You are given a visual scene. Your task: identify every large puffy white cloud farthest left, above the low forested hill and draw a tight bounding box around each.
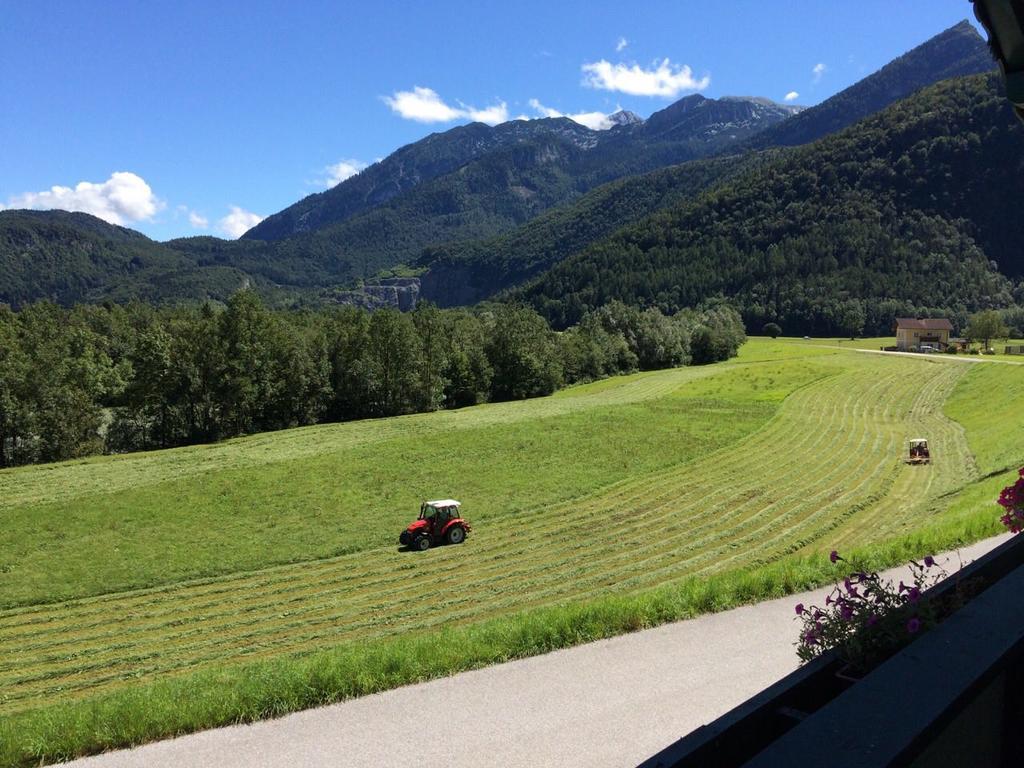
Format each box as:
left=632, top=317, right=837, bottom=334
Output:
left=5, top=171, right=165, bottom=225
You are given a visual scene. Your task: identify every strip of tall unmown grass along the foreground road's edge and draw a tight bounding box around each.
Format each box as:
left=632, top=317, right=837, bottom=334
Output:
left=0, top=495, right=1000, bottom=767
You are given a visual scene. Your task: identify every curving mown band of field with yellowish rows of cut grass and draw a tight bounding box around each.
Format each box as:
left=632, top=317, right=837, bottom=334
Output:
left=0, top=355, right=966, bottom=713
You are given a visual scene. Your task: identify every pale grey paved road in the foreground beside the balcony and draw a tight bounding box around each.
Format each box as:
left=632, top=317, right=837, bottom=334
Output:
left=58, top=537, right=1006, bottom=768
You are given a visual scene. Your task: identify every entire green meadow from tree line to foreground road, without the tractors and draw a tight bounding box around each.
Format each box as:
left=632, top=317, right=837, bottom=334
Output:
left=0, top=340, right=1024, bottom=763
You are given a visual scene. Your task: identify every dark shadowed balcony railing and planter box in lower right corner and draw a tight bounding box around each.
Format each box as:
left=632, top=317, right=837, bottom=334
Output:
left=641, top=537, right=1024, bottom=768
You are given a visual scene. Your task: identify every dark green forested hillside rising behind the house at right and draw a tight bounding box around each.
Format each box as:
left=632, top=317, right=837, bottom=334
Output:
left=515, top=75, right=1024, bottom=334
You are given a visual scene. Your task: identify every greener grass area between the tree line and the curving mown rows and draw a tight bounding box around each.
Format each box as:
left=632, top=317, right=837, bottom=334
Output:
left=0, top=364, right=782, bottom=607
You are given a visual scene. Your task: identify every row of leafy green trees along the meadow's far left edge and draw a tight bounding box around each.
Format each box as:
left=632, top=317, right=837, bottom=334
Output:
left=0, top=291, right=745, bottom=467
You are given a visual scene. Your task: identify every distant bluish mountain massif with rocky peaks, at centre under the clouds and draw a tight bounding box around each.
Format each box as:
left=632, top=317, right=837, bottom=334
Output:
left=244, top=95, right=799, bottom=264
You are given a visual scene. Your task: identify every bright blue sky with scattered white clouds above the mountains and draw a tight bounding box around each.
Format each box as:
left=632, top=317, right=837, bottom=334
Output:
left=0, top=0, right=977, bottom=240
